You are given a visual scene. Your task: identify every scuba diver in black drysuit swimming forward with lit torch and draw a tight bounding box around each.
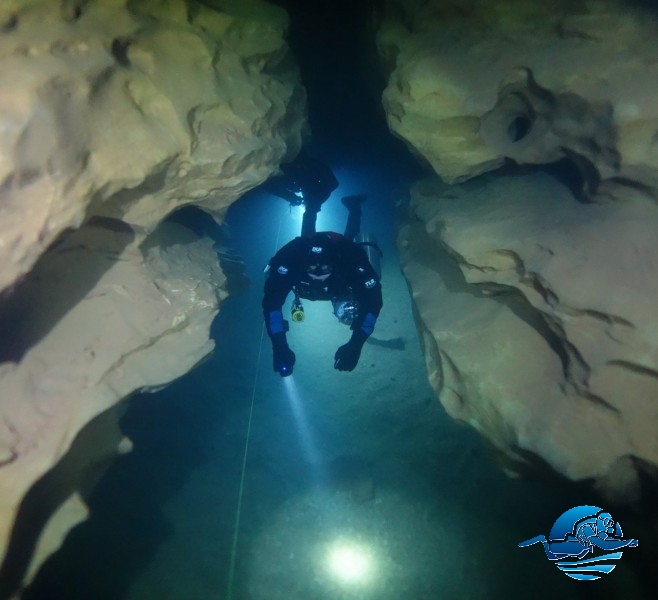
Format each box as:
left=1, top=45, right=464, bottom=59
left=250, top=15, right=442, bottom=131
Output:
left=263, top=157, right=383, bottom=377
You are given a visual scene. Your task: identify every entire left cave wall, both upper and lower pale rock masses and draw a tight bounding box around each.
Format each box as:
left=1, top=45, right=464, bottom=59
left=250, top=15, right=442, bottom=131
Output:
left=0, top=0, right=308, bottom=597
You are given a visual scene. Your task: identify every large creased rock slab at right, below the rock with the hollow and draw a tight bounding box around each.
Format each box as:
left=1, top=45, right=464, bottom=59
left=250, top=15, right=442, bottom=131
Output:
left=400, top=175, right=658, bottom=502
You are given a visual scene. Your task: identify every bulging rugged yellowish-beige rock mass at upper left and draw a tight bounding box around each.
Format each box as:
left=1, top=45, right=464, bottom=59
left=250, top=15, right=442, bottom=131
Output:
left=0, top=0, right=307, bottom=290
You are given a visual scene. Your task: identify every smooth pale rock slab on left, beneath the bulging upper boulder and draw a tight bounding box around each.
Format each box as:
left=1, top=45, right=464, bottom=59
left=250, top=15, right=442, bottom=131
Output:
left=0, top=220, right=225, bottom=587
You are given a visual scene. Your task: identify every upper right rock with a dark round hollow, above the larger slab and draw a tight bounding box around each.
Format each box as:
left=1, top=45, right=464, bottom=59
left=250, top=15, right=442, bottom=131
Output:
left=378, top=0, right=658, bottom=201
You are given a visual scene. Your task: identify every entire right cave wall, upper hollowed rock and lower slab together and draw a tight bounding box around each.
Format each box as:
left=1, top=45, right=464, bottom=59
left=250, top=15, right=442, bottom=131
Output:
left=378, top=0, right=658, bottom=504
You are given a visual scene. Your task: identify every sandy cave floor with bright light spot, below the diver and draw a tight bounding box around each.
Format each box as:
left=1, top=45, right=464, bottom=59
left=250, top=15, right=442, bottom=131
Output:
left=116, top=207, right=630, bottom=600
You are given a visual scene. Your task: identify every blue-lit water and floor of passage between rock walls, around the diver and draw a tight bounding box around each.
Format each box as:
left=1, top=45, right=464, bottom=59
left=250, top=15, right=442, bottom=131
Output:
left=19, top=0, right=648, bottom=600
